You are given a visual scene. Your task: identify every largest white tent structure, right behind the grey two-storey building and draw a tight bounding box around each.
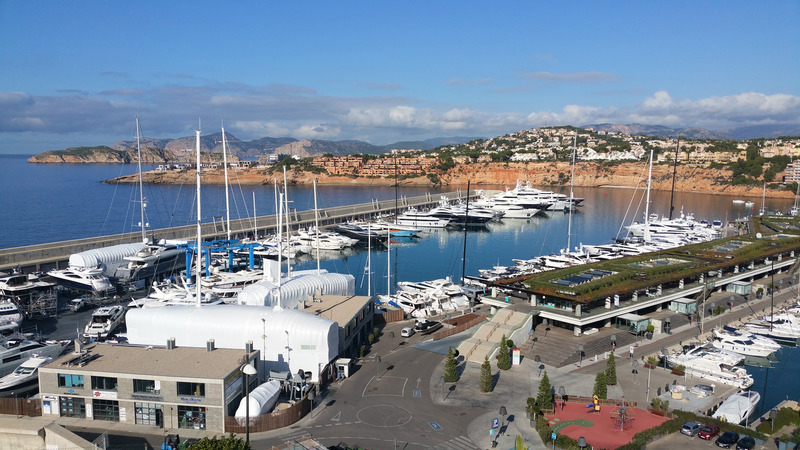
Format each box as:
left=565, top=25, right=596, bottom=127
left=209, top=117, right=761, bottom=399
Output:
left=125, top=305, right=339, bottom=382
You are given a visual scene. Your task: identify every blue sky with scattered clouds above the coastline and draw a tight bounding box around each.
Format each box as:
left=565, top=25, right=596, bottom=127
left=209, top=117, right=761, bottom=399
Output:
left=0, top=0, right=800, bottom=154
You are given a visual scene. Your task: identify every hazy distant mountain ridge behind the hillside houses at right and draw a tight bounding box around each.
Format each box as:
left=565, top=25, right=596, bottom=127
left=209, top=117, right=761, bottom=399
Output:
left=582, top=123, right=800, bottom=141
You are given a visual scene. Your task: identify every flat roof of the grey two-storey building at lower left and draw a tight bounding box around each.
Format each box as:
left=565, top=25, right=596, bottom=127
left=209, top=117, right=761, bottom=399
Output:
left=44, top=342, right=255, bottom=379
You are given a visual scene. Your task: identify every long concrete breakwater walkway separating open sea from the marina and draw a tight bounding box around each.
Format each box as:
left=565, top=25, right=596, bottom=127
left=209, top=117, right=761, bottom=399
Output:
left=0, top=190, right=477, bottom=273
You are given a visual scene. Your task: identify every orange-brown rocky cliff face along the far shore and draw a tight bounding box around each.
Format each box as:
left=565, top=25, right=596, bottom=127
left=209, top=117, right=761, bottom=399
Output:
left=108, top=162, right=794, bottom=198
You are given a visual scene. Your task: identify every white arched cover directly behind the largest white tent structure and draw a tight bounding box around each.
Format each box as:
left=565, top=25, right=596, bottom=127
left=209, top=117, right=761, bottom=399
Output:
left=237, top=270, right=356, bottom=309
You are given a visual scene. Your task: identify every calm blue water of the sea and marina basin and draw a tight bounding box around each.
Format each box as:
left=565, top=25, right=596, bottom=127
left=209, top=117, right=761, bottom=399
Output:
left=0, top=155, right=800, bottom=410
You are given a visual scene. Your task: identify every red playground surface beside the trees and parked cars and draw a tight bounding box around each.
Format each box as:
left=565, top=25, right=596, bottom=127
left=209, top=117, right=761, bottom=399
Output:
left=547, top=402, right=669, bottom=449
